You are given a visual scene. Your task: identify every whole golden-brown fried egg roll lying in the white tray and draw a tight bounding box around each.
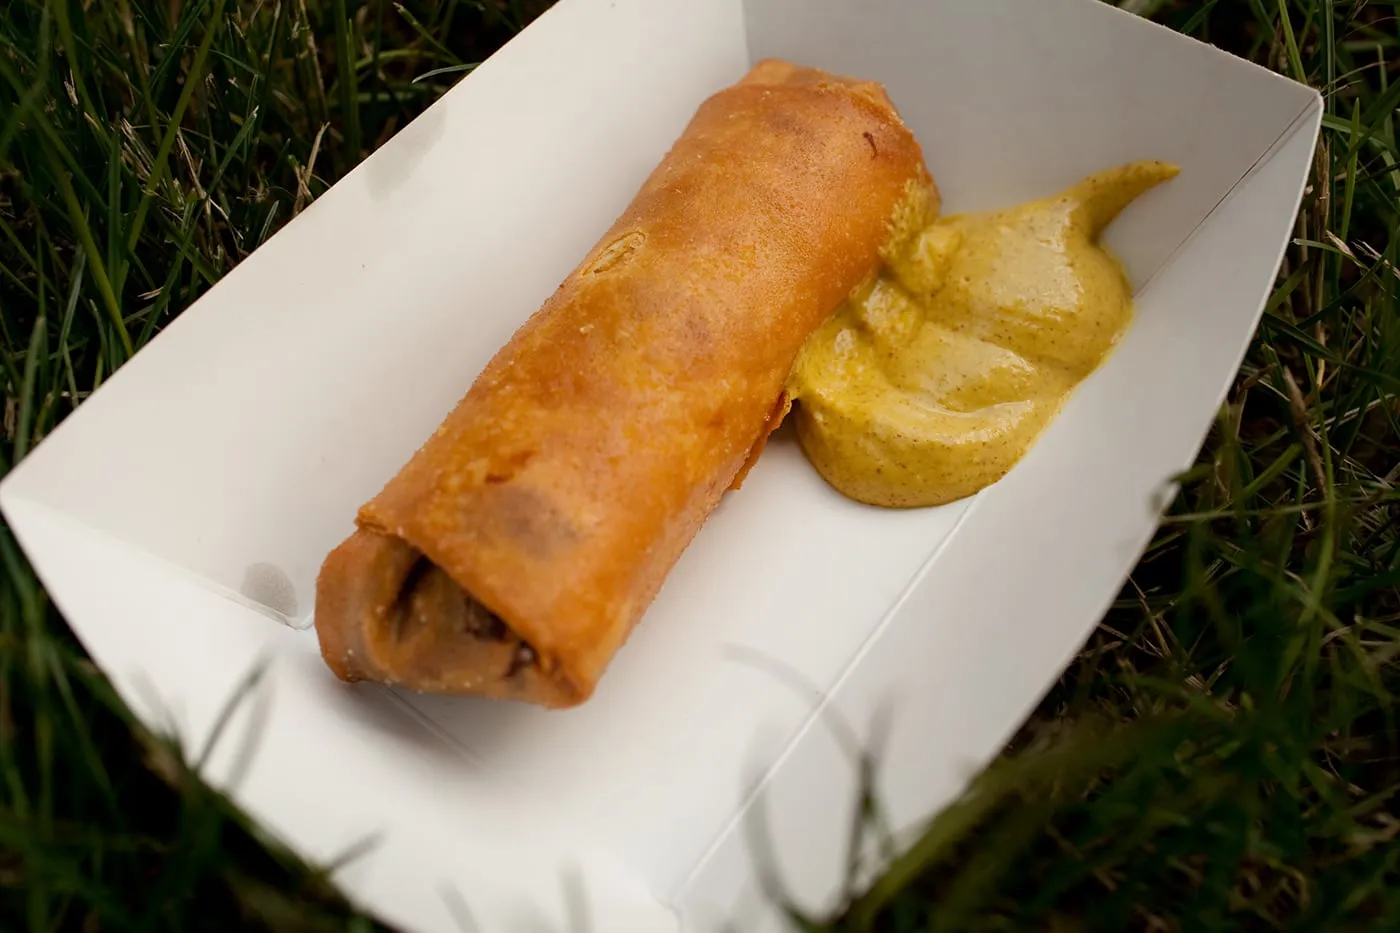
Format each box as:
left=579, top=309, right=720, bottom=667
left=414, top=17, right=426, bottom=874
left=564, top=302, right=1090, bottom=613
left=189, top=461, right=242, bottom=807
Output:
left=315, top=60, right=937, bottom=706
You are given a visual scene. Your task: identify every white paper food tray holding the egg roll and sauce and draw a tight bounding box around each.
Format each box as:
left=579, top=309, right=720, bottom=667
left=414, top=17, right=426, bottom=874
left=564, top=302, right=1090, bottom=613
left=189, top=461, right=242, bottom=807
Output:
left=0, top=0, right=1322, bottom=933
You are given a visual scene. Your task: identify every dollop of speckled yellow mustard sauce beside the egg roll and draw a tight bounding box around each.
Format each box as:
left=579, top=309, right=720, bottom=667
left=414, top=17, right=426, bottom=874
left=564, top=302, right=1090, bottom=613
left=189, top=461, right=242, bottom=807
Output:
left=788, top=161, right=1177, bottom=507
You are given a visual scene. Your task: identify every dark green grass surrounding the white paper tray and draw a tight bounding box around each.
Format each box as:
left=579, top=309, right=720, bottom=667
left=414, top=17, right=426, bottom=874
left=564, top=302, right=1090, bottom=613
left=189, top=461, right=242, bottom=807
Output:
left=0, top=0, right=1400, bottom=933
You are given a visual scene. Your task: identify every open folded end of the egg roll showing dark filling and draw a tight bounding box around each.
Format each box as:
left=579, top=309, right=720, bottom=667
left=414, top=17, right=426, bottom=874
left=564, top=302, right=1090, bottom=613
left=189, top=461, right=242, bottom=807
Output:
left=316, top=528, right=587, bottom=707
